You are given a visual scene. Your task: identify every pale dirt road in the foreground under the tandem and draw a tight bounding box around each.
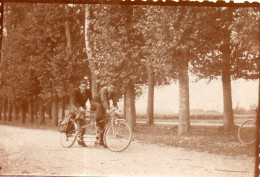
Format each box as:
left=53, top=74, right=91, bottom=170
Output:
left=0, top=125, right=254, bottom=177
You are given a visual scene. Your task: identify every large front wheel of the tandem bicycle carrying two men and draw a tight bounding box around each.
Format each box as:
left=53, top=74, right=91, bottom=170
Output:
left=104, top=120, right=132, bottom=152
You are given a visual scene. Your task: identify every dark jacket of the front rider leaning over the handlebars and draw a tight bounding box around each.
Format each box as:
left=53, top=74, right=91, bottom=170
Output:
left=93, top=87, right=118, bottom=110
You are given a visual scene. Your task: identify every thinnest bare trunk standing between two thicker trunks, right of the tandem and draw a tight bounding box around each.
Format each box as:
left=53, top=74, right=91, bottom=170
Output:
left=146, top=64, right=154, bottom=124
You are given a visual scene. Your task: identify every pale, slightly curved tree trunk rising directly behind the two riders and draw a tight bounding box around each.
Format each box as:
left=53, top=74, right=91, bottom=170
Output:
left=85, top=4, right=99, bottom=97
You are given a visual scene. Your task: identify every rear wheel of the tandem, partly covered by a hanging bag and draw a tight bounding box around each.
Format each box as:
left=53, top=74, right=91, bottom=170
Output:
left=60, top=123, right=77, bottom=148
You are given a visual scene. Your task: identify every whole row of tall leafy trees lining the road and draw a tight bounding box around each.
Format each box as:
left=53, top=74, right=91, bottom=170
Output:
left=1, top=3, right=260, bottom=135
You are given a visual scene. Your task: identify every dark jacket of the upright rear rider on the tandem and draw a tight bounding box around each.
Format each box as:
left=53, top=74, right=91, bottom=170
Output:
left=72, top=89, right=92, bottom=108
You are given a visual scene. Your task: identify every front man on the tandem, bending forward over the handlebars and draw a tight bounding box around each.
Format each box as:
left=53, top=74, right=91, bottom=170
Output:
left=92, top=80, right=118, bottom=148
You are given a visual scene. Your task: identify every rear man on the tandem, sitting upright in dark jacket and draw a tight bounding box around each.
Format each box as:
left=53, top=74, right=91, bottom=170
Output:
left=71, top=80, right=92, bottom=147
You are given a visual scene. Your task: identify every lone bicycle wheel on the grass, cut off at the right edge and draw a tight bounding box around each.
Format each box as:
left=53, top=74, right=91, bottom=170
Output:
left=238, top=120, right=256, bottom=144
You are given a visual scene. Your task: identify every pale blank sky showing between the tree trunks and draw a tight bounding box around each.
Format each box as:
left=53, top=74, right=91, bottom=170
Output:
left=119, top=79, right=259, bottom=114
